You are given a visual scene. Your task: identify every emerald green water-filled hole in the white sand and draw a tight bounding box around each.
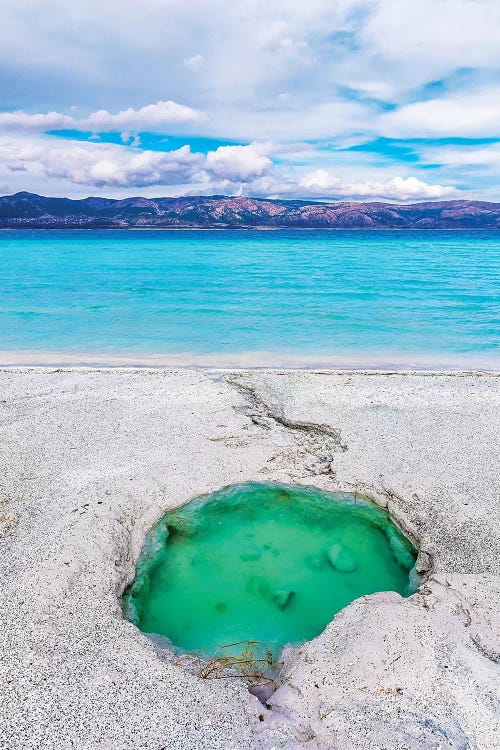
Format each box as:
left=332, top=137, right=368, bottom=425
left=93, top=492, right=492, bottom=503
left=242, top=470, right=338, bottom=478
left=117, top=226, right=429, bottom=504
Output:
left=124, top=483, right=418, bottom=658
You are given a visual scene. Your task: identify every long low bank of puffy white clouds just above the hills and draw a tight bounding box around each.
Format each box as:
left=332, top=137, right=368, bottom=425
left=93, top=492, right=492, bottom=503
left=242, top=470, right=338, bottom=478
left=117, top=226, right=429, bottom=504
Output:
left=0, top=136, right=459, bottom=201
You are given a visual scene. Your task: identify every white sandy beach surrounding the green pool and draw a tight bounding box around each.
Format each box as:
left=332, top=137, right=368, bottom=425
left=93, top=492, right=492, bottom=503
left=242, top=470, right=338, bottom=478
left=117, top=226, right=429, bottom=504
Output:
left=0, top=367, right=500, bottom=750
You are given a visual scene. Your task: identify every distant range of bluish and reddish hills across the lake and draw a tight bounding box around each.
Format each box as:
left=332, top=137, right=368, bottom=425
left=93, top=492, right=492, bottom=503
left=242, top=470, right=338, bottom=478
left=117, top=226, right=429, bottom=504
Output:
left=0, top=193, right=500, bottom=229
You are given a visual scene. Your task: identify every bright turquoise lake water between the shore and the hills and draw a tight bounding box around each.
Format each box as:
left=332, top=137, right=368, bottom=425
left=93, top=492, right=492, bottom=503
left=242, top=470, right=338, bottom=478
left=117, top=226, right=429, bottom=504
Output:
left=0, top=231, right=500, bottom=364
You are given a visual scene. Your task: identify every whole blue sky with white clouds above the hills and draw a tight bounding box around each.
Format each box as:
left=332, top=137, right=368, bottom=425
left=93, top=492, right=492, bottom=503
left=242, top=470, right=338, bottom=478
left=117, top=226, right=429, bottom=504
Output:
left=0, top=0, right=500, bottom=202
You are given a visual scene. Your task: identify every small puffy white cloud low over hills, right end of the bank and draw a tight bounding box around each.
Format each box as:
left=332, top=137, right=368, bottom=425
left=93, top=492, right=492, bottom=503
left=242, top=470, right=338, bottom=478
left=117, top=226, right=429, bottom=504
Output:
left=299, top=169, right=459, bottom=201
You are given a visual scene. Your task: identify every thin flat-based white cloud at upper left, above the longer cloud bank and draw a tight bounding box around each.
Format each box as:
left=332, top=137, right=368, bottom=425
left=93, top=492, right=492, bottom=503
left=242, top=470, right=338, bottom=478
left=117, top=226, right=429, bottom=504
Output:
left=0, top=100, right=206, bottom=133
